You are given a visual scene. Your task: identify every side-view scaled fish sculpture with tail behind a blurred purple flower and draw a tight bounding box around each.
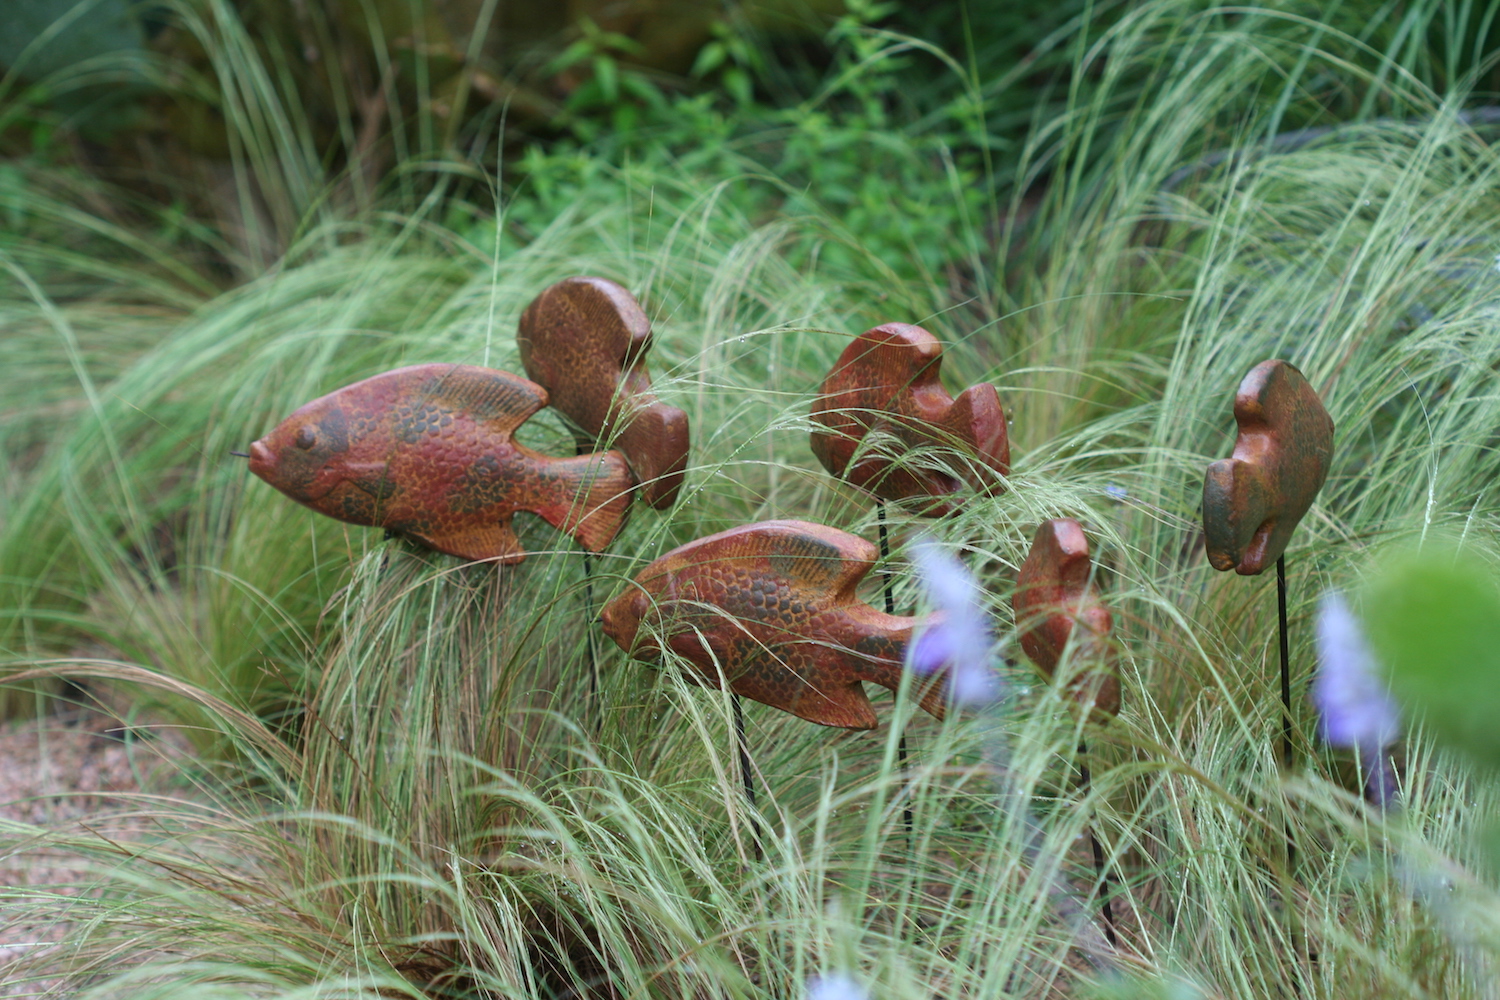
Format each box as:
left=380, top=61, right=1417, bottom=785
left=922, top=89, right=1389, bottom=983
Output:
left=600, top=520, right=947, bottom=729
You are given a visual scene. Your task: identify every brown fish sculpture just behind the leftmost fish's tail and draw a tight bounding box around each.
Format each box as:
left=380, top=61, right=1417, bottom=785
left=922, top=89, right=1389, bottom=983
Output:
left=516, top=277, right=689, bottom=508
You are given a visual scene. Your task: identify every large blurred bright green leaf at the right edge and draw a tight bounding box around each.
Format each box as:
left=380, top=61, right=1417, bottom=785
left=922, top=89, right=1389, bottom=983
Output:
left=1364, top=547, right=1500, bottom=771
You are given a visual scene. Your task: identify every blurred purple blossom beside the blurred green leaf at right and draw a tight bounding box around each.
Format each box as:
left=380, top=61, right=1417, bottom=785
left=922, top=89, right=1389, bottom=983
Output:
left=1313, top=591, right=1401, bottom=807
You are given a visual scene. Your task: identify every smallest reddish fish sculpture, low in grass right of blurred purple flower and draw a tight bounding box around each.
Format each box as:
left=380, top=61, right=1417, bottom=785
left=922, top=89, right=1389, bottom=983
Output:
left=1011, top=517, right=1121, bottom=715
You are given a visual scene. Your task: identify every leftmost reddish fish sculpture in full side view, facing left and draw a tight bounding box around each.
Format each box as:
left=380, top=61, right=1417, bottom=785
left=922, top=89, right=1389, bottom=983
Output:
left=251, top=364, right=633, bottom=562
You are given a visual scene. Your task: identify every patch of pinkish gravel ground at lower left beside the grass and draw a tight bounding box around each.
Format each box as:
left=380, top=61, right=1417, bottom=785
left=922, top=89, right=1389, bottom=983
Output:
left=0, top=709, right=189, bottom=999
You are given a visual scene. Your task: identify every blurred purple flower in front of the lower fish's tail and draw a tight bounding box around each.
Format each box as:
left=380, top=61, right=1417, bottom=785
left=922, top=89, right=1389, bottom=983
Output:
left=906, top=538, right=1001, bottom=706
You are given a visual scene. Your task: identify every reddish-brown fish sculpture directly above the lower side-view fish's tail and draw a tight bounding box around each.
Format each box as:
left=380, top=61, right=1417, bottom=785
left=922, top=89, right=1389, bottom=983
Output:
left=812, top=322, right=1011, bottom=516
